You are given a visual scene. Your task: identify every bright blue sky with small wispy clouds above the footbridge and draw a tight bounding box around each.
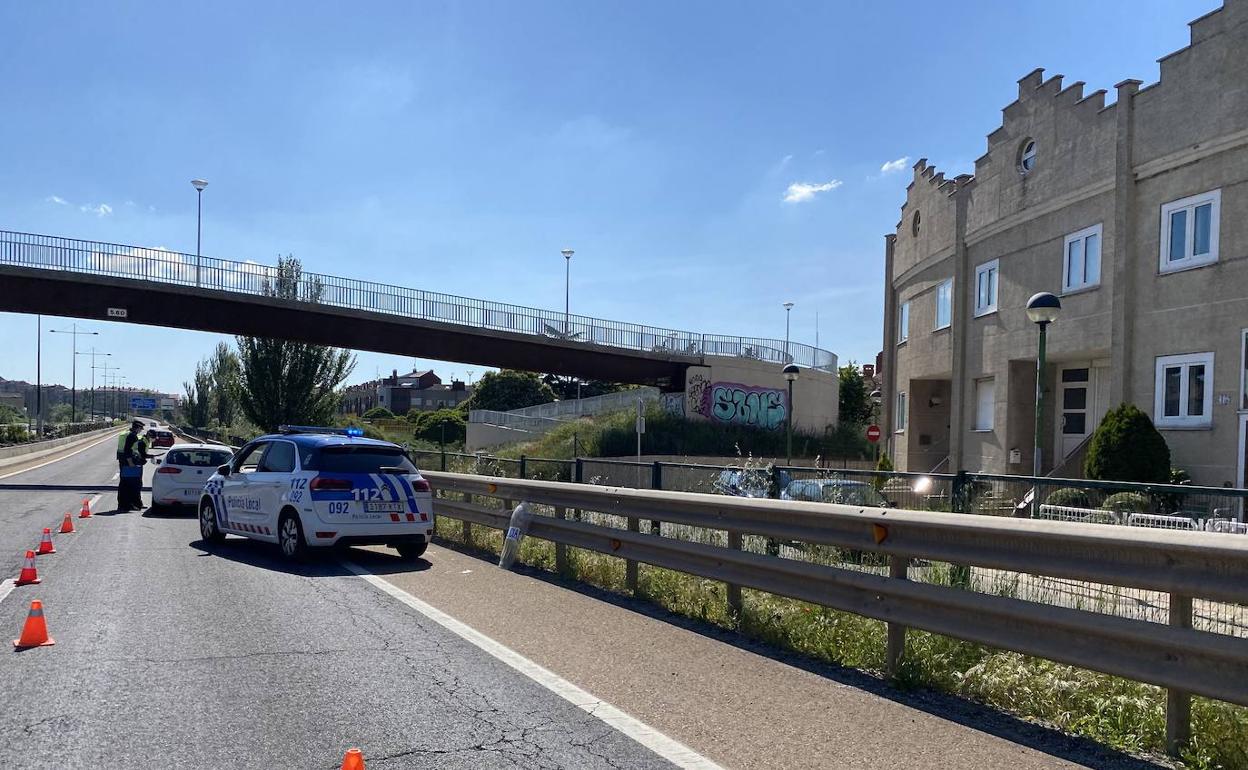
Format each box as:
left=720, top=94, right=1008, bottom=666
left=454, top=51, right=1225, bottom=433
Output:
left=0, top=0, right=1217, bottom=391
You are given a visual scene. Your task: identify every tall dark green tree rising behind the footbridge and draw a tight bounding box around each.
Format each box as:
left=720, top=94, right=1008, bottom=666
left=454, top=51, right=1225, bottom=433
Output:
left=237, top=256, right=356, bottom=431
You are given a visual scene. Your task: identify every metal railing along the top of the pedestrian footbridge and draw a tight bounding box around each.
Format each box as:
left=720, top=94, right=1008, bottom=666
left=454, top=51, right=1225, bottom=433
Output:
left=0, top=231, right=836, bottom=372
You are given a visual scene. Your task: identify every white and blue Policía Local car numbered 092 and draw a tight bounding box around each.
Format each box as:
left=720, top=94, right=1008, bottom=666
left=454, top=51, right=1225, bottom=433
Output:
left=200, top=426, right=433, bottom=559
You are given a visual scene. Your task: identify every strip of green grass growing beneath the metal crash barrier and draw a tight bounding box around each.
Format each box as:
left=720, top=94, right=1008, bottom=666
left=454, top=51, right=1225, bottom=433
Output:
left=437, top=506, right=1248, bottom=770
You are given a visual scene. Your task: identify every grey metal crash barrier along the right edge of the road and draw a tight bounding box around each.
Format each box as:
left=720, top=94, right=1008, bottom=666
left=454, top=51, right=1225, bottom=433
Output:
left=426, top=472, right=1248, bottom=750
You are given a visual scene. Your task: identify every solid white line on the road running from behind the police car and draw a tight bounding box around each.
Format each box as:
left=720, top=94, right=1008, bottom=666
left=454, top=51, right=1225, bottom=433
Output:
left=342, top=562, right=723, bottom=770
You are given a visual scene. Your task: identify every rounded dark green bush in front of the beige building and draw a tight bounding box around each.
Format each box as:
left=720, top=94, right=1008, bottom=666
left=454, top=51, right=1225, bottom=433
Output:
left=1083, top=403, right=1171, bottom=484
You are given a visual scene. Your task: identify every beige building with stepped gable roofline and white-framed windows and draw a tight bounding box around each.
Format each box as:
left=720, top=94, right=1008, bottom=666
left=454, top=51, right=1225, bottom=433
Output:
left=884, top=0, right=1248, bottom=485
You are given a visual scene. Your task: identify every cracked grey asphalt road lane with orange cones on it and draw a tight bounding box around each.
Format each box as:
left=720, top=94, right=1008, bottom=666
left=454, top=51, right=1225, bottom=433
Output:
left=0, top=439, right=673, bottom=769
